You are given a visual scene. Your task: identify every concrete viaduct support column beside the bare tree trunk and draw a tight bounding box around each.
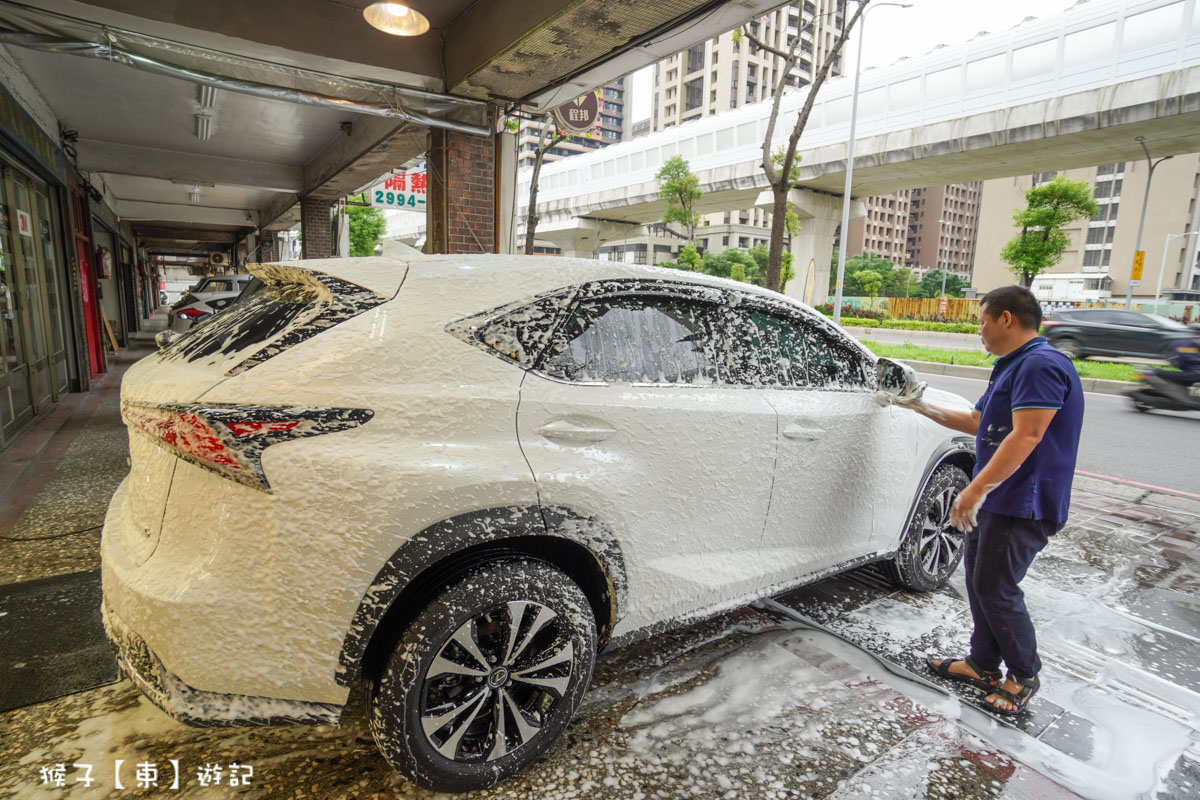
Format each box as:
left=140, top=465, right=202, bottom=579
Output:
left=755, top=188, right=866, bottom=306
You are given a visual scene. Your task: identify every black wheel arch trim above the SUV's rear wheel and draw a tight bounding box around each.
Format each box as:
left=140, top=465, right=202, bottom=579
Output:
left=335, top=506, right=629, bottom=687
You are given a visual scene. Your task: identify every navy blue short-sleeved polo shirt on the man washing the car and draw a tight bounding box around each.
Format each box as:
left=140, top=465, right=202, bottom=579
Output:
left=974, top=336, right=1084, bottom=522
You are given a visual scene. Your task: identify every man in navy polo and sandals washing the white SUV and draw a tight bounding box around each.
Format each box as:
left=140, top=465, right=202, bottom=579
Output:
left=898, top=285, right=1084, bottom=716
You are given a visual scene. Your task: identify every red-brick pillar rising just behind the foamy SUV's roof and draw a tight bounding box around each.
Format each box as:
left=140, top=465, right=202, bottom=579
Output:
left=425, top=128, right=497, bottom=253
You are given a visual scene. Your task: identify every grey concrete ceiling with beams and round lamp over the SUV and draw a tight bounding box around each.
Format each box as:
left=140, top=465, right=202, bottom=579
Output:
left=0, top=0, right=781, bottom=250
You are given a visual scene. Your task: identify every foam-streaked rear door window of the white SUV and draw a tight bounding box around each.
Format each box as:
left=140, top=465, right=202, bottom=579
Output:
left=542, top=295, right=722, bottom=384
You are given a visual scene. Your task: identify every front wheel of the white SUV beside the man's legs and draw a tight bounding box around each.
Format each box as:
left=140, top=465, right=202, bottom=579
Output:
left=883, top=464, right=971, bottom=591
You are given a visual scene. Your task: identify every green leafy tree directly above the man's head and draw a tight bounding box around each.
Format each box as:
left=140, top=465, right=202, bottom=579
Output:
left=1000, top=175, right=1099, bottom=287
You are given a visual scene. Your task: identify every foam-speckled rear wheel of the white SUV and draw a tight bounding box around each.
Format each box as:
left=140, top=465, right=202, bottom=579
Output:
left=366, top=559, right=596, bottom=792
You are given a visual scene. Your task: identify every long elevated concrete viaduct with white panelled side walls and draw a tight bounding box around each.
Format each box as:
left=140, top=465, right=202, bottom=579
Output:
left=517, top=0, right=1200, bottom=299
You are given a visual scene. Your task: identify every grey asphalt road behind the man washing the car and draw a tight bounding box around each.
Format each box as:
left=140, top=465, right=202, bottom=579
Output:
left=922, top=374, right=1200, bottom=494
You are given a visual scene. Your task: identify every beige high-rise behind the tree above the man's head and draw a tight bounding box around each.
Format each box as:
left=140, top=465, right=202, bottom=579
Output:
left=973, top=154, right=1200, bottom=302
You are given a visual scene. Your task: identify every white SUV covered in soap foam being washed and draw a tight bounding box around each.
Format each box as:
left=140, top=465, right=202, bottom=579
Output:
left=102, top=255, right=974, bottom=792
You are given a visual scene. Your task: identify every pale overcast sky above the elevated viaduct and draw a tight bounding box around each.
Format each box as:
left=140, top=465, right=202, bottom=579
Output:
left=632, top=0, right=1076, bottom=122
